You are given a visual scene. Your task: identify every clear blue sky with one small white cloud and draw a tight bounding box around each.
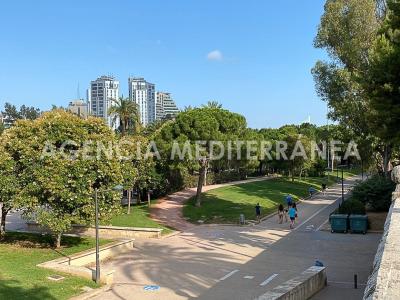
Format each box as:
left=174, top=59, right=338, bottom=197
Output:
left=0, top=0, right=326, bottom=128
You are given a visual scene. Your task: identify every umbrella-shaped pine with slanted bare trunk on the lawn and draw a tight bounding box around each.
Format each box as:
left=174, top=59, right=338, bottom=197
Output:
left=156, top=105, right=246, bottom=206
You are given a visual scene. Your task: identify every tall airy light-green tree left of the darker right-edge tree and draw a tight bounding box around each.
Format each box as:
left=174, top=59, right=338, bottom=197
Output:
left=312, top=0, right=392, bottom=173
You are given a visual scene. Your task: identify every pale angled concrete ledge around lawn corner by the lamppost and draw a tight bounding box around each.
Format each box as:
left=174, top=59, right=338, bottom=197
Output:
left=37, top=240, right=133, bottom=285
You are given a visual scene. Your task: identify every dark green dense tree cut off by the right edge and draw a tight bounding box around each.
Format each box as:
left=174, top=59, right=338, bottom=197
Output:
left=363, top=0, right=400, bottom=165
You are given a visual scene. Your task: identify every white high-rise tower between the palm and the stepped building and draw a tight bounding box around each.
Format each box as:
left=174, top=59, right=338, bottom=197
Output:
left=128, top=77, right=156, bottom=126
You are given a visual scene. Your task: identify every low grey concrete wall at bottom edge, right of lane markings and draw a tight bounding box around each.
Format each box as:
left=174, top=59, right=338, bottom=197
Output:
left=255, top=266, right=326, bottom=300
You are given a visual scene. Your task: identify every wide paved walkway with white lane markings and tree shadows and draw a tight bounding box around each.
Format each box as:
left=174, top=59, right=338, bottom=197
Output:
left=95, top=178, right=381, bottom=300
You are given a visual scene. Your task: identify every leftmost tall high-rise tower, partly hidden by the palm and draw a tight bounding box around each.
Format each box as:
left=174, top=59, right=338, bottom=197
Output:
left=88, top=76, right=119, bottom=128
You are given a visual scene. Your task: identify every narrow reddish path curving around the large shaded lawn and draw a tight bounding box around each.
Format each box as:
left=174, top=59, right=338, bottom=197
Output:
left=150, top=176, right=273, bottom=231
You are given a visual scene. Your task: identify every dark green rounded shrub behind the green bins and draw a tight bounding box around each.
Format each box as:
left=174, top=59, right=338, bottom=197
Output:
left=352, top=175, right=396, bottom=211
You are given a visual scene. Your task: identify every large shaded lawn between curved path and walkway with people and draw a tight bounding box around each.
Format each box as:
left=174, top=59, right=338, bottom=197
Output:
left=183, top=172, right=360, bottom=223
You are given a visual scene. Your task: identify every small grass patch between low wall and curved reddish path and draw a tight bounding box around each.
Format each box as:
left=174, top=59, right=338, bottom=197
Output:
left=108, top=202, right=172, bottom=235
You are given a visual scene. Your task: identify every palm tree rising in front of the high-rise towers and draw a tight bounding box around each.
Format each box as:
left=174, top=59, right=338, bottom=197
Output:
left=108, top=96, right=141, bottom=135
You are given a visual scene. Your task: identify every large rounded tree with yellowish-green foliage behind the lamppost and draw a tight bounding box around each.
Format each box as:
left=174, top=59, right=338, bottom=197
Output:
left=4, top=110, right=122, bottom=247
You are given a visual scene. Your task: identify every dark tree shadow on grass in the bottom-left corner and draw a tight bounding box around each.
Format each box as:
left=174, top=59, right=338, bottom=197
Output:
left=0, top=278, right=56, bottom=300
